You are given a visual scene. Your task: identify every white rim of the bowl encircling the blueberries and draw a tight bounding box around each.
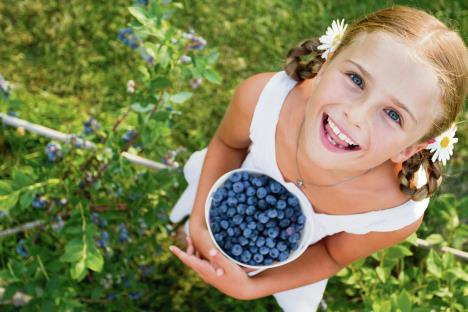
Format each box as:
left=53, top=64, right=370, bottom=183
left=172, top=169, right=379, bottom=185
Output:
left=205, top=168, right=313, bottom=271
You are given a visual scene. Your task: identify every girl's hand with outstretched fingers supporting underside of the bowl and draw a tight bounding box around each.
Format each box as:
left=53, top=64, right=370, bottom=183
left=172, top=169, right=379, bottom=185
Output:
left=169, top=236, right=255, bottom=300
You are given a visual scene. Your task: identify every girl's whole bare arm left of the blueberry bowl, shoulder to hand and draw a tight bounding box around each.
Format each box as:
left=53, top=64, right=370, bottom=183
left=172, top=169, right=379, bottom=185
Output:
left=189, top=73, right=275, bottom=258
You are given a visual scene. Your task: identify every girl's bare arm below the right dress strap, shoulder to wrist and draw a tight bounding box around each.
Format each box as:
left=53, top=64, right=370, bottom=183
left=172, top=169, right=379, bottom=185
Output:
left=248, top=217, right=423, bottom=299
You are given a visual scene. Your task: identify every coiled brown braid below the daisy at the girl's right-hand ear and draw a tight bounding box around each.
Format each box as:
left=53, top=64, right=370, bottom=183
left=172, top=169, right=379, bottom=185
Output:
left=398, top=149, right=442, bottom=201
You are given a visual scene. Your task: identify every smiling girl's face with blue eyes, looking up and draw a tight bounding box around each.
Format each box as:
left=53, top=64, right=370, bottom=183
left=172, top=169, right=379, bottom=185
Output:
left=301, top=33, right=442, bottom=171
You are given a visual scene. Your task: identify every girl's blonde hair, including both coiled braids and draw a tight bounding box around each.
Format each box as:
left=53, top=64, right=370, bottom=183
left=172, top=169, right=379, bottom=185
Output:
left=284, top=6, right=468, bottom=200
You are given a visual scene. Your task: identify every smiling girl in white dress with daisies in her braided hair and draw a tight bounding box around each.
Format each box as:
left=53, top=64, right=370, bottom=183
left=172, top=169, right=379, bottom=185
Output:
left=167, top=6, right=468, bottom=311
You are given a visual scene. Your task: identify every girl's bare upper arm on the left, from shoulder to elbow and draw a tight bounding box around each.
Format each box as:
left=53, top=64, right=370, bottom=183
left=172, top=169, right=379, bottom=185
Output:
left=215, top=72, right=276, bottom=149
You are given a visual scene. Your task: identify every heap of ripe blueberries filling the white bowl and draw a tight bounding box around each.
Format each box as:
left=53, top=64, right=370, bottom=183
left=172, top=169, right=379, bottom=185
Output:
left=209, top=171, right=305, bottom=266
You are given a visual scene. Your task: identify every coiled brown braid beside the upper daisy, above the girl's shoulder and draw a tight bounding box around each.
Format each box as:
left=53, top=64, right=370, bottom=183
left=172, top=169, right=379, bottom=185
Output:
left=284, top=38, right=325, bottom=81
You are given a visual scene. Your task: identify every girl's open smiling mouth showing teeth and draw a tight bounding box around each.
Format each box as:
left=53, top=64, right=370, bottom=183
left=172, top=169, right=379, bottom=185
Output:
left=320, top=113, right=361, bottom=152
